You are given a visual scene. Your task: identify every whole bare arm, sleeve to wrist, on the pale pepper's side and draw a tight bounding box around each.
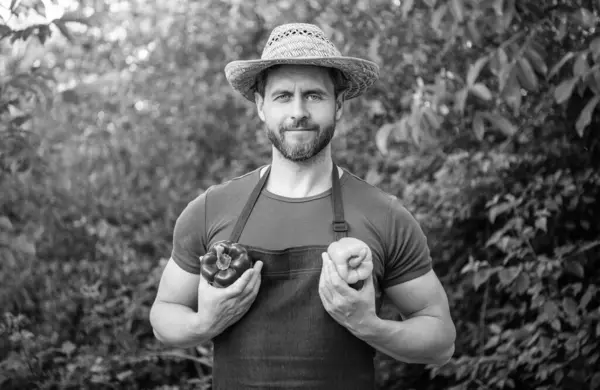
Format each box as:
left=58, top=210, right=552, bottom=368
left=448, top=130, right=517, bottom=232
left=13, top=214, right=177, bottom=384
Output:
left=356, top=271, right=456, bottom=365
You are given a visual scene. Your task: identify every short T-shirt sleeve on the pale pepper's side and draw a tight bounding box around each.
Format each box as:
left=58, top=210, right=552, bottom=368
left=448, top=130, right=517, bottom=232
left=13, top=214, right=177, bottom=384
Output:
left=383, top=196, right=432, bottom=288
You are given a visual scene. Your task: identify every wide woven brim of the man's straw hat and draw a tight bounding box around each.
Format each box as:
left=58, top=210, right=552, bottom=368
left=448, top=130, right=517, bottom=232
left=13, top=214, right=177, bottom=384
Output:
left=225, top=57, right=379, bottom=102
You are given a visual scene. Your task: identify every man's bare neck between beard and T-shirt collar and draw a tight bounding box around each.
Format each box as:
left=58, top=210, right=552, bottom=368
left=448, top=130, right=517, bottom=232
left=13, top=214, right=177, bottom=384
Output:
left=261, top=147, right=341, bottom=198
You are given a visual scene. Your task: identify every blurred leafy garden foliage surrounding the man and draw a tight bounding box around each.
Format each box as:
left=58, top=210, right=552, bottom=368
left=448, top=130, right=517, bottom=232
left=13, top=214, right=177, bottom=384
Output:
left=0, top=0, right=600, bottom=390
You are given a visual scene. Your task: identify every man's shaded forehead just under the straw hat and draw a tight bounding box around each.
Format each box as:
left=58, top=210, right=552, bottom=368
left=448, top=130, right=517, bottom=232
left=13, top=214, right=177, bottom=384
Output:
left=266, top=65, right=333, bottom=89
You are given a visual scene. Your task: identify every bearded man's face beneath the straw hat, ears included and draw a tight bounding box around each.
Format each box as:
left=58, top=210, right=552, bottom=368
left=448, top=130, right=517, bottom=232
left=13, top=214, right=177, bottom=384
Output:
left=255, top=65, right=342, bottom=162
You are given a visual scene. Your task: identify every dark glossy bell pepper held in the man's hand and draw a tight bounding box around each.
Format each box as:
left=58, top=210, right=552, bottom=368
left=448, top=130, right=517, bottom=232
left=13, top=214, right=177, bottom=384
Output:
left=200, top=240, right=252, bottom=287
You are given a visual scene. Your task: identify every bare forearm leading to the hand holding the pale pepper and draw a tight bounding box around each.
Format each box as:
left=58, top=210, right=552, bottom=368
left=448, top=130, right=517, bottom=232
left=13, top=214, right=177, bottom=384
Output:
left=356, top=316, right=456, bottom=365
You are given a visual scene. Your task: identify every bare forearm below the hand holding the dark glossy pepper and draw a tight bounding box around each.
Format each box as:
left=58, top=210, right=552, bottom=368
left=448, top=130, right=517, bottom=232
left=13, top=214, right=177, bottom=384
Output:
left=150, top=302, right=222, bottom=348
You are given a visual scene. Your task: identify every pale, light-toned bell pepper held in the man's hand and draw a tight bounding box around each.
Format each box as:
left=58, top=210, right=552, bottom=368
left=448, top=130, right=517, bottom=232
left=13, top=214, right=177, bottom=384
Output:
left=327, top=237, right=373, bottom=290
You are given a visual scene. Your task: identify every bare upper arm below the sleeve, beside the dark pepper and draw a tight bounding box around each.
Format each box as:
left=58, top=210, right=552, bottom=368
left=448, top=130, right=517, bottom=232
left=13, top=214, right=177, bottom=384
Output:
left=156, top=259, right=200, bottom=310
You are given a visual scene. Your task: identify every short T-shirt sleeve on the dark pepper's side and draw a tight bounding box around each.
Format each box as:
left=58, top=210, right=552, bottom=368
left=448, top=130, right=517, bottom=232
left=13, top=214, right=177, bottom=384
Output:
left=171, top=191, right=208, bottom=274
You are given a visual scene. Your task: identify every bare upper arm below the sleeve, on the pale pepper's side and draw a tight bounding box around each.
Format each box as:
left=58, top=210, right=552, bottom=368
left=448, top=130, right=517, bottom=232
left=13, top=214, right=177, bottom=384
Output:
left=385, top=270, right=450, bottom=321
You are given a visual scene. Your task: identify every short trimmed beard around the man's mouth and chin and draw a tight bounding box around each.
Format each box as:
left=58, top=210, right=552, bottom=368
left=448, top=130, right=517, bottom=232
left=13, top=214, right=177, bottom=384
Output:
left=265, top=120, right=336, bottom=162
